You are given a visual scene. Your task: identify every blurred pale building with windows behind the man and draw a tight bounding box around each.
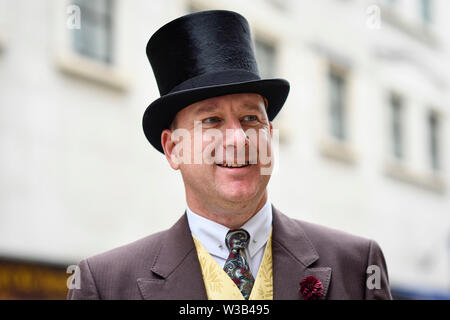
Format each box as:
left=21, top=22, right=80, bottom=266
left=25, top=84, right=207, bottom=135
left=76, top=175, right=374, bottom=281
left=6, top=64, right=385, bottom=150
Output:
left=0, top=0, right=450, bottom=299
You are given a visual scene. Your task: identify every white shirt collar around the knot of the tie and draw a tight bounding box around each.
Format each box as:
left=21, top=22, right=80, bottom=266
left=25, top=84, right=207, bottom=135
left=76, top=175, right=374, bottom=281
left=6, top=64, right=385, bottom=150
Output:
left=186, top=199, right=272, bottom=259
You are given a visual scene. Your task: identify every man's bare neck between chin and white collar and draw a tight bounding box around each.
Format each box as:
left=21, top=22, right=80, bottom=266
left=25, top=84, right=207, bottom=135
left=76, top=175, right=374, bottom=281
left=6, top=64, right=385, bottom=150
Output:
left=186, top=190, right=267, bottom=229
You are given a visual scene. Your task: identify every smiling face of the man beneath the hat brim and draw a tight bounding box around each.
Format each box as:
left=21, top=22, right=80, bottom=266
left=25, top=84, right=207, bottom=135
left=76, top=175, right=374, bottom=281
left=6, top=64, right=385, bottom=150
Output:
left=161, top=93, right=272, bottom=210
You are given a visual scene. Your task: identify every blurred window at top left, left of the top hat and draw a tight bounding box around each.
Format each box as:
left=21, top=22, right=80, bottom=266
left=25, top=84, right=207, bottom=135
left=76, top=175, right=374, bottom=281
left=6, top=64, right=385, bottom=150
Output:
left=72, top=0, right=113, bottom=64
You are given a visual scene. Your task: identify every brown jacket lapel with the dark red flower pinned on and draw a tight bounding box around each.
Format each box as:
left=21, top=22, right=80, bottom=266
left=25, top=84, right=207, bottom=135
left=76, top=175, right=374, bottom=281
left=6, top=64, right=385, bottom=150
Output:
left=272, top=206, right=331, bottom=300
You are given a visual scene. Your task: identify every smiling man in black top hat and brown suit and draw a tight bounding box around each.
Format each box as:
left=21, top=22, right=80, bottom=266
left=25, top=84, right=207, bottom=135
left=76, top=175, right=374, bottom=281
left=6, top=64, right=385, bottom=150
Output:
left=68, top=10, right=391, bottom=300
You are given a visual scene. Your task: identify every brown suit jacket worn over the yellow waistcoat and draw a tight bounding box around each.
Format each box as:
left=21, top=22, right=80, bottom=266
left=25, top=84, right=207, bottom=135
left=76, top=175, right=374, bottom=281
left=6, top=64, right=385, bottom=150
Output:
left=67, top=208, right=392, bottom=300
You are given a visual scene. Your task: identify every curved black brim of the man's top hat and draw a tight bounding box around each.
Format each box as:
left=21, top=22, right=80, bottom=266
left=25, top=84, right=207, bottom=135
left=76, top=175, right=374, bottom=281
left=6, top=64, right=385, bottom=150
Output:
left=142, top=79, right=289, bottom=153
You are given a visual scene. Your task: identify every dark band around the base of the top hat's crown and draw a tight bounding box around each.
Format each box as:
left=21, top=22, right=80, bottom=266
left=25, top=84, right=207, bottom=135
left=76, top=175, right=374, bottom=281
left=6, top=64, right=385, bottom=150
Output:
left=168, top=69, right=261, bottom=93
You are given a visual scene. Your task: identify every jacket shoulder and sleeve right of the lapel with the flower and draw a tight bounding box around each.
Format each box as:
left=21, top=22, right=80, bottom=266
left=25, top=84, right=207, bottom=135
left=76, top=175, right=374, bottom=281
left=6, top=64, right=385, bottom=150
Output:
left=274, top=211, right=392, bottom=299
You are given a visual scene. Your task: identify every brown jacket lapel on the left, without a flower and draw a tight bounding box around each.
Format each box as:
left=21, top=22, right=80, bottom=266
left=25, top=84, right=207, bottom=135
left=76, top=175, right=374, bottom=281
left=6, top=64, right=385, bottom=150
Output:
left=137, top=214, right=207, bottom=300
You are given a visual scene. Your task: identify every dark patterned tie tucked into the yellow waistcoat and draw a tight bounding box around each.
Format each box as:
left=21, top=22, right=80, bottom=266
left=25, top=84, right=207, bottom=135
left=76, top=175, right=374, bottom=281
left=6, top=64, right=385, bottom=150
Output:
left=223, top=229, right=255, bottom=300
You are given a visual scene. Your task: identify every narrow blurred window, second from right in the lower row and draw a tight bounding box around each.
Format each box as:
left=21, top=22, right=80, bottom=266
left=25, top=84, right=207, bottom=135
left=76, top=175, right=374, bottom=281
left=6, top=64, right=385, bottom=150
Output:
left=390, top=94, right=404, bottom=159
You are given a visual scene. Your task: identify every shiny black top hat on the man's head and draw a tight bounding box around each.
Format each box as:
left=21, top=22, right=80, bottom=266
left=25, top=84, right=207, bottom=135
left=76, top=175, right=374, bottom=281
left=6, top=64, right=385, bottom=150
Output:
left=142, top=10, right=289, bottom=152
